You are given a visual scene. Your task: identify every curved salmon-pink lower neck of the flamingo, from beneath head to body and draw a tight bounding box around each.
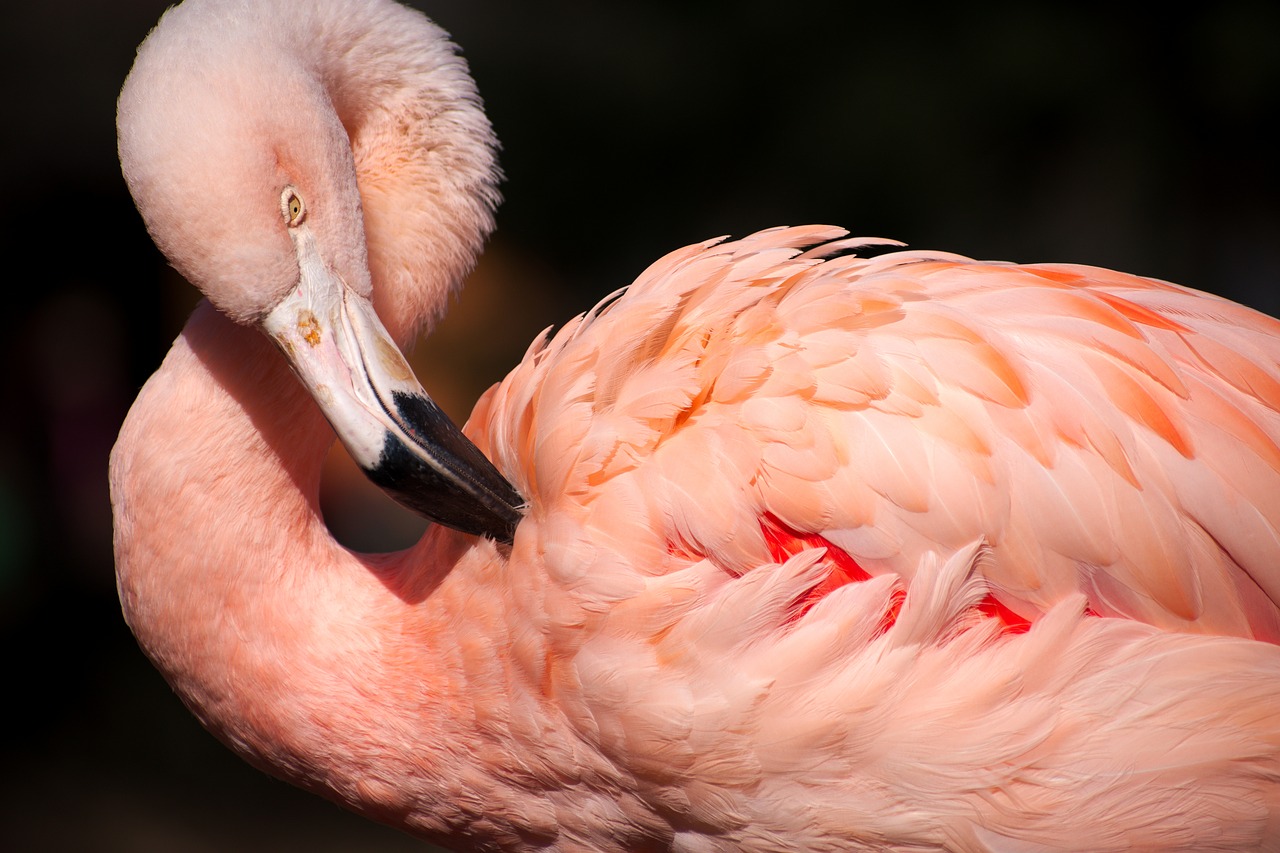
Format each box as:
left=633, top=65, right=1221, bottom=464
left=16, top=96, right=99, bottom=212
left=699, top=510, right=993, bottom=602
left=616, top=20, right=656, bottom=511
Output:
left=111, top=304, right=503, bottom=831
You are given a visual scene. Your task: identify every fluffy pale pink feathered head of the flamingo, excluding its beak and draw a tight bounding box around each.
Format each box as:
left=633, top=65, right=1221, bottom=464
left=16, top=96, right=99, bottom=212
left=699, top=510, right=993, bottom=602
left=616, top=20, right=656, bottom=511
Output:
left=118, top=0, right=498, bottom=343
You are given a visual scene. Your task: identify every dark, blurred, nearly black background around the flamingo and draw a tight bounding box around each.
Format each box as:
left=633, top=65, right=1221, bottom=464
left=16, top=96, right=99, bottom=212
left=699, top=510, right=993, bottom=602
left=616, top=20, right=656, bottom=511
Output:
left=0, top=0, right=1280, bottom=850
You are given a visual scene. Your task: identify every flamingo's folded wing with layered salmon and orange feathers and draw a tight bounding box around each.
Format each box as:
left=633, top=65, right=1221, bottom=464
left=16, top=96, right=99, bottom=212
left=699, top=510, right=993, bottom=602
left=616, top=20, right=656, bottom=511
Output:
left=477, top=227, right=1280, bottom=640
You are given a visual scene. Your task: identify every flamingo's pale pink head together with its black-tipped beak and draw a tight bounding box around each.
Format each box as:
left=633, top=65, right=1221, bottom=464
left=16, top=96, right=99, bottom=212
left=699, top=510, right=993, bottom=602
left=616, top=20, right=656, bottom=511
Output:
left=118, top=0, right=521, bottom=539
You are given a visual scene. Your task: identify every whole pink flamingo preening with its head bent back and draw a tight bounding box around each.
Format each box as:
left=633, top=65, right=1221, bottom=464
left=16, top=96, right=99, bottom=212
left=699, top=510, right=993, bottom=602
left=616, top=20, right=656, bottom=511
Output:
left=110, top=0, right=1280, bottom=852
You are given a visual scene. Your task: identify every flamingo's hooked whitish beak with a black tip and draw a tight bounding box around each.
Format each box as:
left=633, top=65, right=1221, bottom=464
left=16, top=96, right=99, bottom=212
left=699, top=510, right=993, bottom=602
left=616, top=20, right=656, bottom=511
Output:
left=262, top=229, right=524, bottom=543
